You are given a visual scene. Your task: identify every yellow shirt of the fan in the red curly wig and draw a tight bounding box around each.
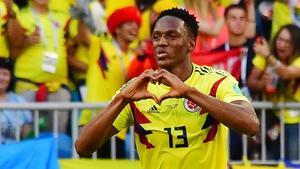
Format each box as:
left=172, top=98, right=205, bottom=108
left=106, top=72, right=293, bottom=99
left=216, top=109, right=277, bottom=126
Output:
left=80, top=35, right=134, bottom=125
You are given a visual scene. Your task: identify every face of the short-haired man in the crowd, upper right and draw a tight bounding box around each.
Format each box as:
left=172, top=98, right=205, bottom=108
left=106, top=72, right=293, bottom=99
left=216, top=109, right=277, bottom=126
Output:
left=226, top=8, right=247, bottom=35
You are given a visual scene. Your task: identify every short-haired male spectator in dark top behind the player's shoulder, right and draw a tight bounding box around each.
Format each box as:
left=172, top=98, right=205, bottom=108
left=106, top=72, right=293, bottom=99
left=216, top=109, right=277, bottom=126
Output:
left=213, top=1, right=255, bottom=160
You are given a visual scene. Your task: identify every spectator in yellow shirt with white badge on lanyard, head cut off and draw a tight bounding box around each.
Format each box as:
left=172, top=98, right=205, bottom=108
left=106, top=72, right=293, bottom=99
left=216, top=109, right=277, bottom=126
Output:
left=8, top=0, right=70, bottom=133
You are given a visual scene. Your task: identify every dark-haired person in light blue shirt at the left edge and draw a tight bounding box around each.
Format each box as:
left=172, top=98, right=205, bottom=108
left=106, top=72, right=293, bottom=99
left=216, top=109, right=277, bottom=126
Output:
left=0, top=57, right=32, bottom=144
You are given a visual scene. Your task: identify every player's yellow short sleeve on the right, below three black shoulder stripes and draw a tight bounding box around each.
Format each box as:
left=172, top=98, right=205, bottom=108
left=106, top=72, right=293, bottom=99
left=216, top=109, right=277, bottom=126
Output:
left=217, top=75, right=249, bottom=103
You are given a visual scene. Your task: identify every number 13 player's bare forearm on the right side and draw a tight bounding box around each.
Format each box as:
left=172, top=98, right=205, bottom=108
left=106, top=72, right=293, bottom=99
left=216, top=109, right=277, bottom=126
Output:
left=186, top=88, right=259, bottom=135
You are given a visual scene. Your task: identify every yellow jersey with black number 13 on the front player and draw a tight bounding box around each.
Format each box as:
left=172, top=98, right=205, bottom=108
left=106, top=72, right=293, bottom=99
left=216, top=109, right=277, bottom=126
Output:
left=113, top=65, right=247, bottom=169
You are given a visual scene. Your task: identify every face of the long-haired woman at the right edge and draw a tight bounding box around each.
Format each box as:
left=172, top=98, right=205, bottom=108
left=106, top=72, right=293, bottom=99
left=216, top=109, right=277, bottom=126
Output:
left=275, top=29, right=294, bottom=60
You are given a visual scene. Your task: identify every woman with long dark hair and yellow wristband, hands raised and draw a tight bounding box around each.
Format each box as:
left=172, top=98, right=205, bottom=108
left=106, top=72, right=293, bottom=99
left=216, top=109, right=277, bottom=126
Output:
left=248, top=24, right=300, bottom=160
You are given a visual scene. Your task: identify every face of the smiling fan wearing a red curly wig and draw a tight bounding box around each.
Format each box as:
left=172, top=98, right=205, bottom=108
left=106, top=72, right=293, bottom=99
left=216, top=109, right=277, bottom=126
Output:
left=116, top=22, right=139, bottom=43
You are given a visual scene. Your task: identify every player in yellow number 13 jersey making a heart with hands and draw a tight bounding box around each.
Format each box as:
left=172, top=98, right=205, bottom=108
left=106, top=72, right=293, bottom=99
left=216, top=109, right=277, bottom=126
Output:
left=75, top=8, right=259, bottom=169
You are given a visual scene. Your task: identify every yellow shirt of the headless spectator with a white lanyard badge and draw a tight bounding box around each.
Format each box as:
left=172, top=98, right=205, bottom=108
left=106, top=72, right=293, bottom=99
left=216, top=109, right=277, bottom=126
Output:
left=15, top=5, right=69, bottom=92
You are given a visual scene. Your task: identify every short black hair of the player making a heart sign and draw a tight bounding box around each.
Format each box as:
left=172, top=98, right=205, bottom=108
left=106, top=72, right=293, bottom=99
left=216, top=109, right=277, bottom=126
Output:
left=152, top=8, right=199, bottom=37
